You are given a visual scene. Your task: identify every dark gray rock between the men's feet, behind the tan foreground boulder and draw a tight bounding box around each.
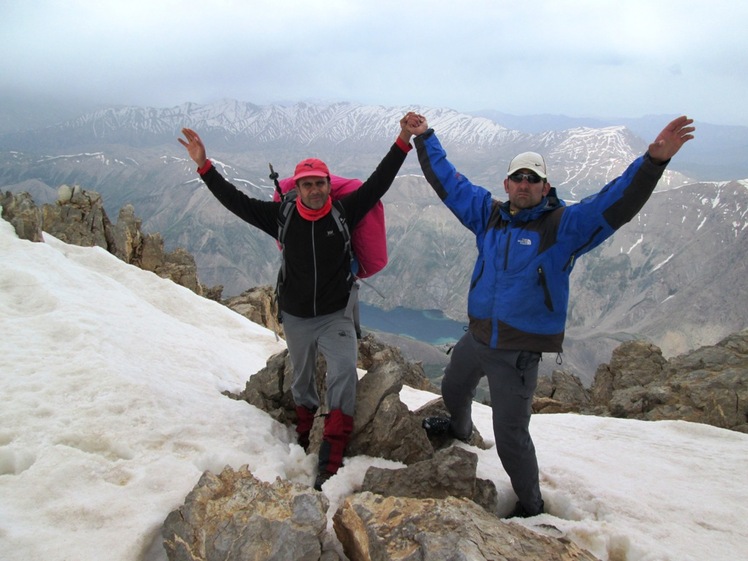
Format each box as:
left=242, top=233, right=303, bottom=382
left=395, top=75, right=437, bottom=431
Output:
left=361, top=446, right=498, bottom=514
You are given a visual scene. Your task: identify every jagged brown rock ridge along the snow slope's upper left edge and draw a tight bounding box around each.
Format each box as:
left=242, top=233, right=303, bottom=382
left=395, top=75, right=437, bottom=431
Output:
left=0, top=185, right=223, bottom=300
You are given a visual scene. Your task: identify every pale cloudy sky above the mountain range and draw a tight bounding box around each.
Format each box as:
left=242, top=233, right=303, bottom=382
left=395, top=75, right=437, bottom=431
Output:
left=0, top=0, right=748, bottom=126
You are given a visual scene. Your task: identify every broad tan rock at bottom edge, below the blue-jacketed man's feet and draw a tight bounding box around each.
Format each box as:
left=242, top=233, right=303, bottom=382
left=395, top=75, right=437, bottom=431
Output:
left=333, top=492, right=597, bottom=561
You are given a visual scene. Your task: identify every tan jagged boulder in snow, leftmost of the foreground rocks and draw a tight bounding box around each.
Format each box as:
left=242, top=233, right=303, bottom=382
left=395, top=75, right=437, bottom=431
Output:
left=161, top=466, right=329, bottom=561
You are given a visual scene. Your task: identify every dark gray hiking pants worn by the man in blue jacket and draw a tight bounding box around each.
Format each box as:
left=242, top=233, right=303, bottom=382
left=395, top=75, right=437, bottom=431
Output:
left=442, top=333, right=543, bottom=512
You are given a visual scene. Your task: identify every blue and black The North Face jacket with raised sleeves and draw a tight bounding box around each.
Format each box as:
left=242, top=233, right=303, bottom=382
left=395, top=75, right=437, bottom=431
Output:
left=415, top=129, right=667, bottom=353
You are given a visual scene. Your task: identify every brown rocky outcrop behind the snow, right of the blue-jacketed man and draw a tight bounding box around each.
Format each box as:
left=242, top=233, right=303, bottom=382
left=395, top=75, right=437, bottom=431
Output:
left=533, top=330, right=748, bottom=433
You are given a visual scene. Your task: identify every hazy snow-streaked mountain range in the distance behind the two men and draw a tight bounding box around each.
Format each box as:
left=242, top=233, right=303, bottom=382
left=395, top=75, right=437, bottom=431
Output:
left=0, top=100, right=748, bottom=381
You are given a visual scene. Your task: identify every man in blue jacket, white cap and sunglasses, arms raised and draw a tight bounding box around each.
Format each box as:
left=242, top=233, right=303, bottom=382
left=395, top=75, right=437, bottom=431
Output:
left=411, top=117, right=695, bottom=517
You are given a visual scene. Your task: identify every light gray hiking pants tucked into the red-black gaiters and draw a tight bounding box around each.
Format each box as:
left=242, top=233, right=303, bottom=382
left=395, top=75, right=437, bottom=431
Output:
left=283, top=310, right=358, bottom=416
